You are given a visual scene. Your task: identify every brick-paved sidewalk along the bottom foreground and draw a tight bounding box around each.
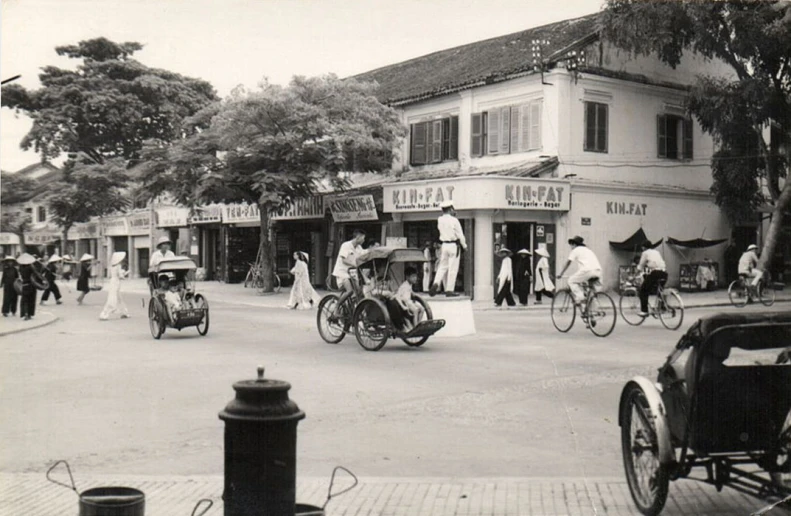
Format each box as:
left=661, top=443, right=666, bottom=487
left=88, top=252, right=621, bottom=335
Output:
left=0, top=474, right=789, bottom=516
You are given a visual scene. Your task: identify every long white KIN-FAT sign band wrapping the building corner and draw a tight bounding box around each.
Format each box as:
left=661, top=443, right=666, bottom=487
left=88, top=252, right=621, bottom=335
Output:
left=384, top=176, right=570, bottom=213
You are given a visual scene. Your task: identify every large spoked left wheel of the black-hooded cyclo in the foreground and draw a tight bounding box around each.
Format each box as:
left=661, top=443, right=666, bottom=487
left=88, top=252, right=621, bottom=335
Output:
left=621, top=384, right=669, bottom=516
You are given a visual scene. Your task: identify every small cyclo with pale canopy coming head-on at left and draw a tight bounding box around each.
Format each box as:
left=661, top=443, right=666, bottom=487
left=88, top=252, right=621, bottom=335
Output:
left=148, top=256, right=209, bottom=339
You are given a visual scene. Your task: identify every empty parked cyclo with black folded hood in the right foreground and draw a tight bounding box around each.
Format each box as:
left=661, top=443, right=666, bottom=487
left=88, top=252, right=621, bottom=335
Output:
left=618, top=313, right=791, bottom=515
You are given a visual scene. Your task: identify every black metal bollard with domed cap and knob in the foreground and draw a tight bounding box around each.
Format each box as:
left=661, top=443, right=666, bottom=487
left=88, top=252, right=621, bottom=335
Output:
left=219, top=367, right=305, bottom=516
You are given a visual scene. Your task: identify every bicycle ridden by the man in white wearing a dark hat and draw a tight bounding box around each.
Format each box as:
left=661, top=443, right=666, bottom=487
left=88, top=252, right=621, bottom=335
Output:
left=550, top=278, right=618, bottom=337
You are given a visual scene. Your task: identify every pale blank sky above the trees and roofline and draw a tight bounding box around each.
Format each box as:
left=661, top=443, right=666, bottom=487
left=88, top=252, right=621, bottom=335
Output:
left=0, top=0, right=603, bottom=171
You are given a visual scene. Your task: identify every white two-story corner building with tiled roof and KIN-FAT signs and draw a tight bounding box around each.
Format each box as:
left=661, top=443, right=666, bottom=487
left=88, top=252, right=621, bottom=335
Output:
left=356, top=15, right=730, bottom=300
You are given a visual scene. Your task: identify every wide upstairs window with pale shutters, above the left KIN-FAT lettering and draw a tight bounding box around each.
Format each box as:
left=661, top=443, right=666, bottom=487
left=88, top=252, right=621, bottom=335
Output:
left=471, top=100, right=542, bottom=156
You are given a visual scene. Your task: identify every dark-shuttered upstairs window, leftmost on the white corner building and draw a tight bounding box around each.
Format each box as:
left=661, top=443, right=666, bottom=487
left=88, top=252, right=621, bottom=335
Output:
left=409, top=116, right=459, bottom=165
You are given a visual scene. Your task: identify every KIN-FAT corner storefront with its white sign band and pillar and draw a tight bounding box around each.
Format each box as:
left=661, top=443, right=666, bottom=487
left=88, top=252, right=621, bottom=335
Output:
left=383, top=176, right=570, bottom=300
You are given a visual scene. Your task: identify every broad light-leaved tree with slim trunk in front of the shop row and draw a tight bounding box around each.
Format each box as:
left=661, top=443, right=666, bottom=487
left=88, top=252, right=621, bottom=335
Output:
left=138, top=75, right=406, bottom=290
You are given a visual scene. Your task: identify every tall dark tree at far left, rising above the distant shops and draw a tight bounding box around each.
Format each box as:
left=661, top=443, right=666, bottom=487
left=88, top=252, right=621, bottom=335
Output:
left=2, top=38, right=217, bottom=252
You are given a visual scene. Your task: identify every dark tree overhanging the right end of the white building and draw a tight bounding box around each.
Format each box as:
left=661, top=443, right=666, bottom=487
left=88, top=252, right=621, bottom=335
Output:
left=599, top=0, right=791, bottom=270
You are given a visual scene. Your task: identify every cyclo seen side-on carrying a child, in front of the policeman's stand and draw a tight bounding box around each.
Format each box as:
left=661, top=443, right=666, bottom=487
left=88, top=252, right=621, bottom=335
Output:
left=316, top=247, right=445, bottom=351
